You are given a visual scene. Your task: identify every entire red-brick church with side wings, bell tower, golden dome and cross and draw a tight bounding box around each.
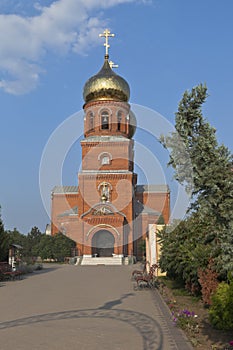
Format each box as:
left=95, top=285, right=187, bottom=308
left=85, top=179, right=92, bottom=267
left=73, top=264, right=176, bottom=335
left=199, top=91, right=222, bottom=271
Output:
left=51, top=29, right=170, bottom=260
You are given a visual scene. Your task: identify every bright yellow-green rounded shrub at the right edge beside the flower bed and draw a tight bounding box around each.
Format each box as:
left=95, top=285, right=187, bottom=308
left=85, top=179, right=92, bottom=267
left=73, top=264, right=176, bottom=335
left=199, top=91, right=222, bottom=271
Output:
left=209, top=277, right=233, bottom=330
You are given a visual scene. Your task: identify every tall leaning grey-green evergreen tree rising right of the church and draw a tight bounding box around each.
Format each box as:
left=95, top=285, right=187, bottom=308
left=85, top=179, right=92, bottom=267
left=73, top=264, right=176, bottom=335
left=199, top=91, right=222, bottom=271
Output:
left=161, top=84, right=233, bottom=286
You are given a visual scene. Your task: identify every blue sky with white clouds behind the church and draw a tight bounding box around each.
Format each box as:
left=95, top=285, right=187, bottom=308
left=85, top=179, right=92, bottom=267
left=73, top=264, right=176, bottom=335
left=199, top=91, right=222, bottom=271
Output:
left=0, top=0, right=233, bottom=233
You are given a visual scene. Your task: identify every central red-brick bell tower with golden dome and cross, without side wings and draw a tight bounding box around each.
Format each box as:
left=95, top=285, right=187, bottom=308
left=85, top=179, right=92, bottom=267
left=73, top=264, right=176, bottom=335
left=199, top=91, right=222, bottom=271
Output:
left=78, top=29, right=137, bottom=256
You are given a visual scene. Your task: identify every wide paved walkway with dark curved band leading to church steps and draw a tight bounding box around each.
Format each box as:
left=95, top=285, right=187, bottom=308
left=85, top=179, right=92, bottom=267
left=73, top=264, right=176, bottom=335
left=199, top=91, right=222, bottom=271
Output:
left=0, top=265, right=192, bottom=350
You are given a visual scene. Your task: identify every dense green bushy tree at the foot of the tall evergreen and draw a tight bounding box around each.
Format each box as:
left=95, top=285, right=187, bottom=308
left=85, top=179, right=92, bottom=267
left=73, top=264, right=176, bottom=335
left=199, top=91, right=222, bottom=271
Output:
left=157, top=214, right=211, bottom=294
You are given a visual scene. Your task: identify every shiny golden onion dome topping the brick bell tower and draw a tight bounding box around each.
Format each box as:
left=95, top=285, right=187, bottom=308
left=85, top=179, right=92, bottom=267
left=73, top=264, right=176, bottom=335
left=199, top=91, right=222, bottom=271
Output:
left=83, top=57, right=130, bottom=103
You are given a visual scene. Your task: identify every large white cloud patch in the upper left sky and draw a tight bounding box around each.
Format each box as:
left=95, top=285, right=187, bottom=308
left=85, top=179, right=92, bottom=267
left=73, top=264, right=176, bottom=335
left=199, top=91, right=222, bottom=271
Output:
left=0, top=0, right=141, bottom=95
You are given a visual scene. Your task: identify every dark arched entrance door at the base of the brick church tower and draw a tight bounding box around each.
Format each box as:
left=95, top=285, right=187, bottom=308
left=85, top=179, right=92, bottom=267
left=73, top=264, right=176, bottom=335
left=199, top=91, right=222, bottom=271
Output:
left=92, top=230, right=115, bottom=257
